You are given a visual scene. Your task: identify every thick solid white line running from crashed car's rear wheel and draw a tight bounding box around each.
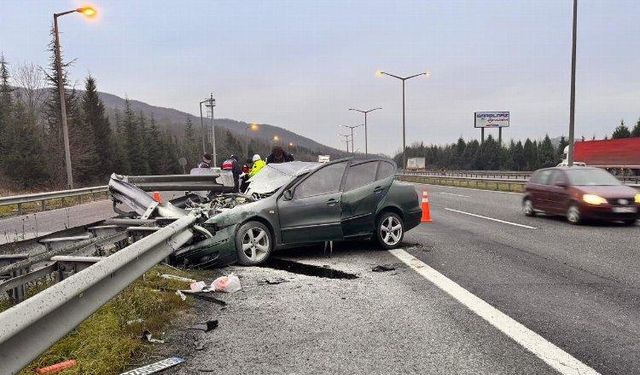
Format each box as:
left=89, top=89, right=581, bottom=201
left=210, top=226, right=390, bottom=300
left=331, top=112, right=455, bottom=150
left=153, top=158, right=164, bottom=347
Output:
left=389, top=249, right=598, bottom=375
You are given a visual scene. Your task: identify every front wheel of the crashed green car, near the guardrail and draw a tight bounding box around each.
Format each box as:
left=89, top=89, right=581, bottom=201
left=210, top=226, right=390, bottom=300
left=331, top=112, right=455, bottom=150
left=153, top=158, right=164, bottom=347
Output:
left=236, top=221, right=273, bottom=266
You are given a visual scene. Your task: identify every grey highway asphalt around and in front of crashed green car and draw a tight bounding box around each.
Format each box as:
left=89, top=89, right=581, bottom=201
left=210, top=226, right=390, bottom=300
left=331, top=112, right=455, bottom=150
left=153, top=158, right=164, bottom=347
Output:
left=156, top=185, right=640, bottom=374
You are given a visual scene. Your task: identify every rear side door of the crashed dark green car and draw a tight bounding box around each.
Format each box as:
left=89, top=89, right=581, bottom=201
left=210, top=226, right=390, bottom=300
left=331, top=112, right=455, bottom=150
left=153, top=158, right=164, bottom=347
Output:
left=340, top=160, right=382, bottom=238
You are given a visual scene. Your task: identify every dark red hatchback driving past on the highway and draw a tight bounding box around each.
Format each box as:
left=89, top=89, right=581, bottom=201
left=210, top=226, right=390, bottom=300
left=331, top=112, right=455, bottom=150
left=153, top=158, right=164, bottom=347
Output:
left=522, top=167, right=640, bottom=225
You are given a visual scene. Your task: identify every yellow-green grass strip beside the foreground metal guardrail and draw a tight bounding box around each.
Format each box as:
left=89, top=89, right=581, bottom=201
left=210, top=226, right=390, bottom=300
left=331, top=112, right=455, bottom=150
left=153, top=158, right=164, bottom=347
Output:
left=0, top=265, right=195, bottom=375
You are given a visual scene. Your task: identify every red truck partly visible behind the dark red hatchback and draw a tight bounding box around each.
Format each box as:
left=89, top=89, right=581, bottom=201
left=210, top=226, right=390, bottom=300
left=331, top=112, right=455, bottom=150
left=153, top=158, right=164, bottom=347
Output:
left=563, top=137, right=640, bottom=175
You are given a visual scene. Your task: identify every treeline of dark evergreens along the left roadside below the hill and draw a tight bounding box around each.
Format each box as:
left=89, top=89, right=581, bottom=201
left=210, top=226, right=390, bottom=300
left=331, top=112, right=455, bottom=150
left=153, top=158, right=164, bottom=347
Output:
left=0, top=48, right=317, bottom=191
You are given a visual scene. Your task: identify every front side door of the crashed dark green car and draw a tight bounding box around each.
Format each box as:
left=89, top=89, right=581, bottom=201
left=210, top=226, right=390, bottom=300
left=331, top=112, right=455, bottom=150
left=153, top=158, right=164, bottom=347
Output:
left=278, top=161, right=347, bottom=244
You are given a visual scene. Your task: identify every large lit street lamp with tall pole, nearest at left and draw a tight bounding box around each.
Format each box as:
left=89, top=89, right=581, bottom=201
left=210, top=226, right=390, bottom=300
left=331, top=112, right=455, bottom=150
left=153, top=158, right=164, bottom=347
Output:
left=53, top=7, right=97, bottom=189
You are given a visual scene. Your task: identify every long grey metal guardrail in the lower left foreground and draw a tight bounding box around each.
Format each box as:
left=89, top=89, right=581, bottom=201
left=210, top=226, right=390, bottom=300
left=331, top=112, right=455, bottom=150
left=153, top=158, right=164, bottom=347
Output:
left=0, top=215, right=196, bottom=374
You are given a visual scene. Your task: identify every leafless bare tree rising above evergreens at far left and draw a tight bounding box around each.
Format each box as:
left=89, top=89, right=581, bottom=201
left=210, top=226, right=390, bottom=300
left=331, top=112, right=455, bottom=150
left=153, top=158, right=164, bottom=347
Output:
left=13, top=63, right=47, bottom=131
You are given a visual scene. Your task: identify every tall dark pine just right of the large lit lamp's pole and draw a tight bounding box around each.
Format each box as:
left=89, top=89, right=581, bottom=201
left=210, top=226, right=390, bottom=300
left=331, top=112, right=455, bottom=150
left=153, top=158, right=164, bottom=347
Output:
left=82, top=76, right=115, bottom=179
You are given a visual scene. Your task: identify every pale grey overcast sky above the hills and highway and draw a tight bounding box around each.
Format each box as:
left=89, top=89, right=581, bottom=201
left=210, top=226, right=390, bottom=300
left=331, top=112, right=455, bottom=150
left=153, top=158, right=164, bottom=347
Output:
left=0, top=0, right=640, bottom=153
